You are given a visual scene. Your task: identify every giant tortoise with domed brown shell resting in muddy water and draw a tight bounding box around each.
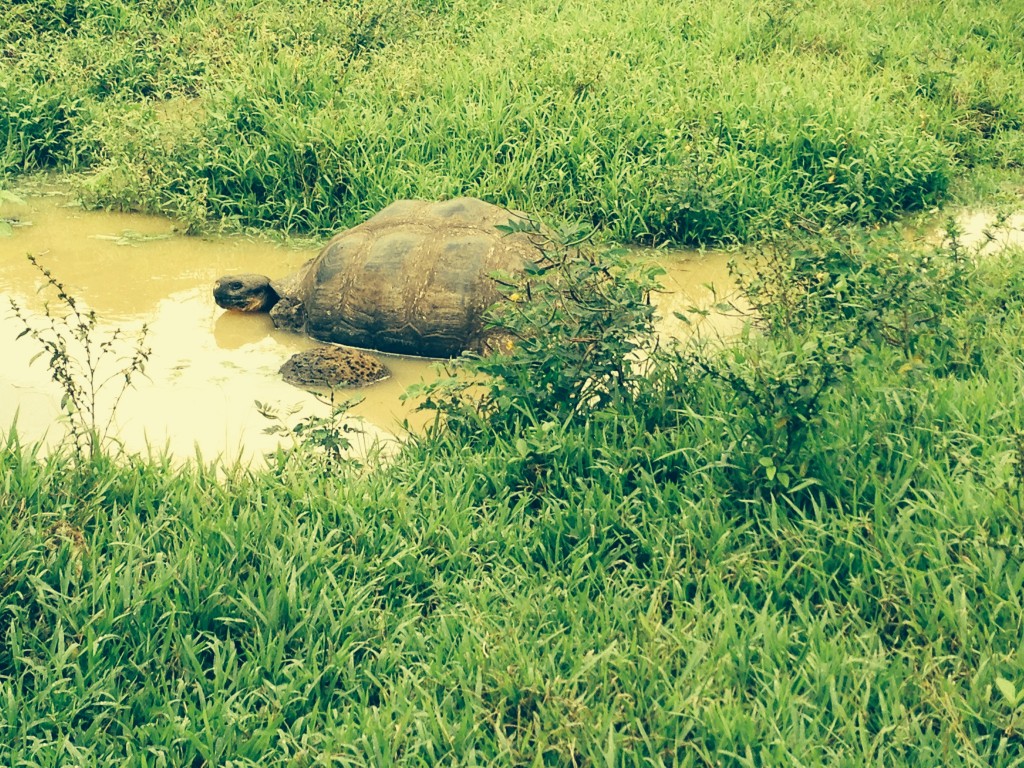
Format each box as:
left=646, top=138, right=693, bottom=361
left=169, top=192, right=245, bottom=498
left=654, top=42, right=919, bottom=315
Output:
left=213, top=198, right=538, bottom=357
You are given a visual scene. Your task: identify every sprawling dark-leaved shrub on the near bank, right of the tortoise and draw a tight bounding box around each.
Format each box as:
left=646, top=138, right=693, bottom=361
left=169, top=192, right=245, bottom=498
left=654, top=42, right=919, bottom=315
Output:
left=674, top=222, right=986, bottom=509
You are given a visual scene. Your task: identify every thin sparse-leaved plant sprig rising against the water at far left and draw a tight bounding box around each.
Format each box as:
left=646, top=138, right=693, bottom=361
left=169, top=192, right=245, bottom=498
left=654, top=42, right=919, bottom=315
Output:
left=10, top=254, right=152, bottom=460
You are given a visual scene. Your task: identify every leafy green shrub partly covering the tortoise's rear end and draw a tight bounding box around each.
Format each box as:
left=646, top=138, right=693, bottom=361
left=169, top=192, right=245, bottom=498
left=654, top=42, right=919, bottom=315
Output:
left=413, top=221, right=659, bottom=430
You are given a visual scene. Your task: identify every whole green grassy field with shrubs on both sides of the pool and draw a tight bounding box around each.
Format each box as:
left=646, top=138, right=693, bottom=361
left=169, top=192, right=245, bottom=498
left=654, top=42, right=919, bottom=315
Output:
left=0, top=0, right=1024, bottom=768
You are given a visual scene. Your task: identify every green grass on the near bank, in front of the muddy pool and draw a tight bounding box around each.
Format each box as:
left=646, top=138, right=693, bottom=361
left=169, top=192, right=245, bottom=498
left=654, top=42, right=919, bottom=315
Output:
left=0, top=231, right=1024, bottom=766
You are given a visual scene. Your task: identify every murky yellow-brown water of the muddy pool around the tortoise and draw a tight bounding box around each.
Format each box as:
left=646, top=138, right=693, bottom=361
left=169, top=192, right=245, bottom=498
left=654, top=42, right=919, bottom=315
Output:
left=6, top=188, right=1024, bottom=461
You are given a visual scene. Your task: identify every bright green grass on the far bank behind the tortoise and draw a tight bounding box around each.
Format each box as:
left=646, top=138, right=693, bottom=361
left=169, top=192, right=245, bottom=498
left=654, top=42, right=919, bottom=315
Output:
left=0, top=0, right=1024, bottom=243
